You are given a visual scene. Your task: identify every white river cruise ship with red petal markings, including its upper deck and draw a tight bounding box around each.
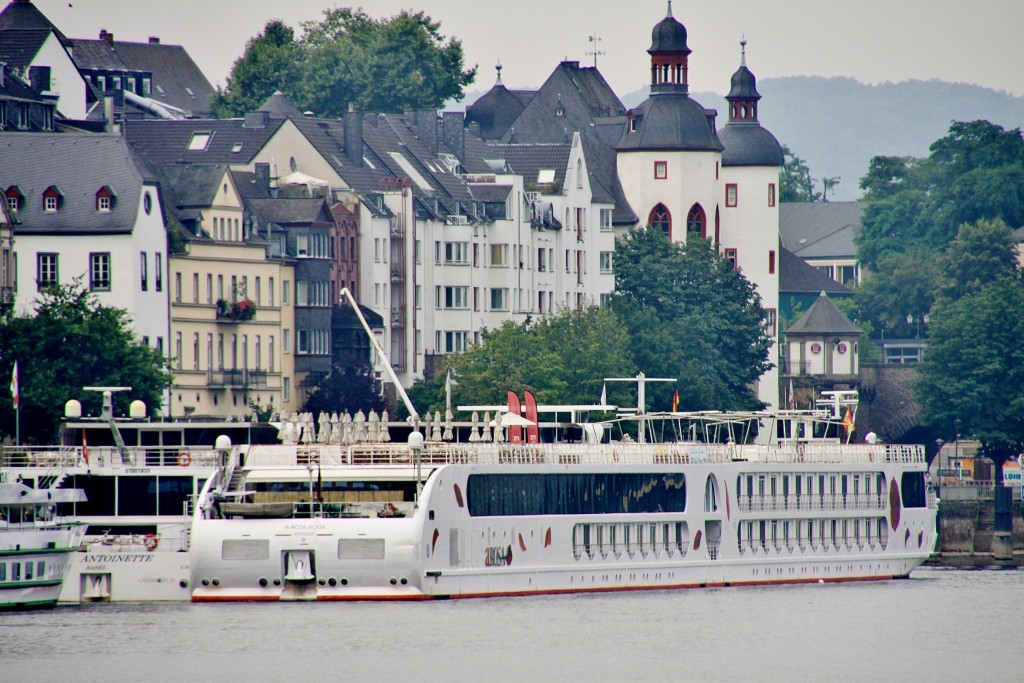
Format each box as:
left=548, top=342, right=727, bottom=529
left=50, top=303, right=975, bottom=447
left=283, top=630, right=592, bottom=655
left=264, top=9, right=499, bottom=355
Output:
left=188, top=392, right=936, bottom=601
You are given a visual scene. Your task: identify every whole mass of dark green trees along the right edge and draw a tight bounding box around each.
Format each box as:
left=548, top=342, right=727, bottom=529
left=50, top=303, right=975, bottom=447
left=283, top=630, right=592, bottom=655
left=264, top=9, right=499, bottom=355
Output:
left=853, top=121, right=1024, bottom=478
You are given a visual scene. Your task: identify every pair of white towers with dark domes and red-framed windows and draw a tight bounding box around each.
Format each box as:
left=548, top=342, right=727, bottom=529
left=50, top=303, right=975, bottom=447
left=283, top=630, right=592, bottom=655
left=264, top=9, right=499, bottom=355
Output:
left=615, top=7, right=782, bottom=417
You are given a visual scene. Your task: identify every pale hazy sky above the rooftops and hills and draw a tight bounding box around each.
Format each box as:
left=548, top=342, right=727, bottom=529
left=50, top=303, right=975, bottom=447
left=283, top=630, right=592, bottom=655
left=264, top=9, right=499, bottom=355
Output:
left=34, top=0, right=1024, bottom=96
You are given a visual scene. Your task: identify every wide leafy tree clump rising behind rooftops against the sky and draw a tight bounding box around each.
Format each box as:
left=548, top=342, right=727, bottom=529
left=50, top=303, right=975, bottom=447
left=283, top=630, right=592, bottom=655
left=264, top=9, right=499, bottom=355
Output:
left=215, top=7, right=476, bottom=117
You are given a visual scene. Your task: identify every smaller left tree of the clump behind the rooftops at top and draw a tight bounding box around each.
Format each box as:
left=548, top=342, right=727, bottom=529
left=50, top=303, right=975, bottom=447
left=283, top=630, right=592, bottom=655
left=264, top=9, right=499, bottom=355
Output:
left=213, top=19, right=303, bottom=118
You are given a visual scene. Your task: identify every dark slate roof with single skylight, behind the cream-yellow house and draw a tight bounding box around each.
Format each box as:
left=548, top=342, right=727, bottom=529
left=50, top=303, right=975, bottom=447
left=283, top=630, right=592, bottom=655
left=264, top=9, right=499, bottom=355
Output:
left=124, top=117, right=285, bottom=165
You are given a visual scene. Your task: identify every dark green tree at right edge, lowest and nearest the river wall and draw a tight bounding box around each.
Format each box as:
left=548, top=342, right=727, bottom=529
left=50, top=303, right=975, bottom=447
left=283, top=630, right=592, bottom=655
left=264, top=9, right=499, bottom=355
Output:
left=916, top=274, right=1024, bottom=483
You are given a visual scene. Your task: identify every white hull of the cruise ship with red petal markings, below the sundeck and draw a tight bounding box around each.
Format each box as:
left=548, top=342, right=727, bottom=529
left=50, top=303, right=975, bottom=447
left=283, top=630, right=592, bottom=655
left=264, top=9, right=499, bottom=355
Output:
left=191, top=446, right=936, bottom=601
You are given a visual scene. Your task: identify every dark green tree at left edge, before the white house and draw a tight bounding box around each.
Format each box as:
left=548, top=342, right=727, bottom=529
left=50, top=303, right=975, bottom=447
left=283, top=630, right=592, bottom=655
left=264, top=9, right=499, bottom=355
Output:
left=0, top=282, right=171, bottom=443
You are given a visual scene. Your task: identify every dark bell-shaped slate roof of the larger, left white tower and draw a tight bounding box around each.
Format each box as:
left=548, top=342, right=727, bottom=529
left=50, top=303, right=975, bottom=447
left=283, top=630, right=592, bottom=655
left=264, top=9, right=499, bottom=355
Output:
left=615, top=92, right=722, bottom=152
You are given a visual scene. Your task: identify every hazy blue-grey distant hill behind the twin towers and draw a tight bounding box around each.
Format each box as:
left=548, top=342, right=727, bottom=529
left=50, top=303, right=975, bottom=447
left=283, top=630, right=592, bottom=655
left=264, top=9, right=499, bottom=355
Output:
left=622, top=76, right=1024, bottom=201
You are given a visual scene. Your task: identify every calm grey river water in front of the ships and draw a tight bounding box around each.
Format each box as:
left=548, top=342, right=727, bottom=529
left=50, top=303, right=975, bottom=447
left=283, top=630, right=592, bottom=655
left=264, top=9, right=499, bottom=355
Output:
left=0, top=568, right=1024, bottom=683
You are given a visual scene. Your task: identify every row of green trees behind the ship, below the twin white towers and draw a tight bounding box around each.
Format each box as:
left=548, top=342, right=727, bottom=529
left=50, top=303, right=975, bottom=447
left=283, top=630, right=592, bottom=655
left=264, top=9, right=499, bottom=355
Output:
left=410, top=229, right=770, bottom=412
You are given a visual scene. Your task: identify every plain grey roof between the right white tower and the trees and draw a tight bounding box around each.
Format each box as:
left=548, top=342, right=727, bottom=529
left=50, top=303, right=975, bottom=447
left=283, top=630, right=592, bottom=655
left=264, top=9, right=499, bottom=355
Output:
left=778, top=202, right=864, bottom=259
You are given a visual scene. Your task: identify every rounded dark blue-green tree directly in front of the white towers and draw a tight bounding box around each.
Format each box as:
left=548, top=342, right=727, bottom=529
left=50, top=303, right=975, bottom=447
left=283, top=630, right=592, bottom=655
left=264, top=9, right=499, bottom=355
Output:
left=612, top=229, right=771, bottom=410
